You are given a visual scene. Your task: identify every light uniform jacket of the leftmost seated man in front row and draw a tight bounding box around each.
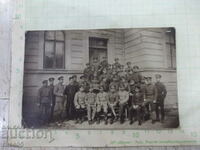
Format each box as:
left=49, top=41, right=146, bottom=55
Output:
left=74, top=91, right=86, bottom=108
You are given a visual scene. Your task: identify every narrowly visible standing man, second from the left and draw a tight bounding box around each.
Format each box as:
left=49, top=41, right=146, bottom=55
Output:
left=49, top=78, right=55, bottom=121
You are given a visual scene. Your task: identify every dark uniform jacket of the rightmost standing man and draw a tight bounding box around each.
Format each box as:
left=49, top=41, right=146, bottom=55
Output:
left=155, top=82, right=167, bottom=100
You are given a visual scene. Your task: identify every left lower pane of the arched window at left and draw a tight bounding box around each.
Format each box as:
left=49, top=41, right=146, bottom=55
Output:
left=44, top=41, right=54, bottom=68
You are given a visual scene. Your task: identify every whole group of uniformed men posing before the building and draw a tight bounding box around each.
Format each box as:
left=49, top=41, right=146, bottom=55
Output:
left=38, top=58, right=167, bottom=125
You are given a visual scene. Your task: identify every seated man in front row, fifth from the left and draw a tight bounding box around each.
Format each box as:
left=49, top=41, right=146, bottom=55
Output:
left=118, top=84, right=129, bottom=124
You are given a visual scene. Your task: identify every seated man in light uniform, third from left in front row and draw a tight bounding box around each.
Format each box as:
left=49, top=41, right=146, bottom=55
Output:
left=96, top=86, right=108, bottom=124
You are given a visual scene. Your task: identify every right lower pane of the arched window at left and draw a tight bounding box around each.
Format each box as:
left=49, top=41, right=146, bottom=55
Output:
left=56, top=42, right=64, bottom=68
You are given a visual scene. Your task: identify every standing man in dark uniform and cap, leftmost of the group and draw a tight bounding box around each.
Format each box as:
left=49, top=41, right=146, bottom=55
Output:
left=38, top=80, right=51, bottom=124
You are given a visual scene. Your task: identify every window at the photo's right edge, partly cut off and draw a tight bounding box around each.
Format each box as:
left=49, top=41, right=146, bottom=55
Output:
left=165, top=28, right=176, bottom=69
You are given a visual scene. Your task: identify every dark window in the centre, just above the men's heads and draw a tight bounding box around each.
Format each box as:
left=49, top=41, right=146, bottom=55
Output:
left=89, top=37, right=108, bottom=63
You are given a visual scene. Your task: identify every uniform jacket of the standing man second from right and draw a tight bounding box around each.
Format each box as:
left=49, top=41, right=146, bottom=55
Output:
left=144, top=84, right=157, bottom=100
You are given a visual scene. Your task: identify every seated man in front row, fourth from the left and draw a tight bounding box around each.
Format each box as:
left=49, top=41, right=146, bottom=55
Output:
left=108, top=86, right=119, bottom=124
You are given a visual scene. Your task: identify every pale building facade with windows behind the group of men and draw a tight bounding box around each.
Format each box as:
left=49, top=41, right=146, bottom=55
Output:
left=23, top=28, right=177, bottom=120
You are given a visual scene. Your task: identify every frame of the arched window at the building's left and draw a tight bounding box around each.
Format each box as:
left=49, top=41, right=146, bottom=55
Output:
left=43, top=31, right=65, bottom=70
